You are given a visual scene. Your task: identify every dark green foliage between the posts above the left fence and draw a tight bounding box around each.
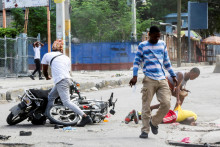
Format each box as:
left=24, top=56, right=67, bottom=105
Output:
left=11, top=3, right=56, bottom=41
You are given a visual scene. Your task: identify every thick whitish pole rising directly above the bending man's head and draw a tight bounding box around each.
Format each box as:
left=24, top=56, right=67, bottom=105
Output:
left=54, top=0, right=66, bottom=54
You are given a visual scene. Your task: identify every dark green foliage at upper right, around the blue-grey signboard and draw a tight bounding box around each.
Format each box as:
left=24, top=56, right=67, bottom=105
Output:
left=138, top=0, right=220, bottom=37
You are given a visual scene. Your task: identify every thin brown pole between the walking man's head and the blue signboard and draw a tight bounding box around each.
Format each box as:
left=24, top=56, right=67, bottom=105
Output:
left=177, top=0, right=181, bottom=67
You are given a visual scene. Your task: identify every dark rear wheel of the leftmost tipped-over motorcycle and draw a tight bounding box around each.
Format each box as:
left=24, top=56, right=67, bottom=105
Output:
left=6, top=112, right=27, bottom=125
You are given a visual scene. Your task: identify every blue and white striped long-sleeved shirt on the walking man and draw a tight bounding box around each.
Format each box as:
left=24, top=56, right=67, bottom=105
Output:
left=133, top=40, right=176, bottom=80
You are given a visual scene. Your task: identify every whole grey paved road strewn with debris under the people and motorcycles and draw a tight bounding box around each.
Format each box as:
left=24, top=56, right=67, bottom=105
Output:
left=0, top=66, right=220, bottom=147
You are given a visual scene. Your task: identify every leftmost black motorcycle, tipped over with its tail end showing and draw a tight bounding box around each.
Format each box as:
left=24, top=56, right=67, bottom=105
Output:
left=6, top=89, right=50, bottom=125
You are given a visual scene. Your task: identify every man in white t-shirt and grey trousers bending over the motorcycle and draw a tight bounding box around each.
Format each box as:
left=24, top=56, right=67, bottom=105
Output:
left=41, top=40, right=92, bottom=127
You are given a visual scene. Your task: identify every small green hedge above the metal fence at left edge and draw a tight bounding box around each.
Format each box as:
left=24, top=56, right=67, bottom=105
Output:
left=0, top=28, right=18, bottom=38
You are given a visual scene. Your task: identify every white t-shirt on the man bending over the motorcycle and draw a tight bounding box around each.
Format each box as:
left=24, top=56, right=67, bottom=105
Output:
left=41, top=52, right=71, bottom=84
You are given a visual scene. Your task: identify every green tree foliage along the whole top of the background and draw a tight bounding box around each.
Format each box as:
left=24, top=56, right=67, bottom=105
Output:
left=8, top=0, right=220, bottom=42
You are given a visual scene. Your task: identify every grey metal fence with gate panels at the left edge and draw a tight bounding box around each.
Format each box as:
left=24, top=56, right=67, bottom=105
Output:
left=0, top=34, right=37, bottom=77
